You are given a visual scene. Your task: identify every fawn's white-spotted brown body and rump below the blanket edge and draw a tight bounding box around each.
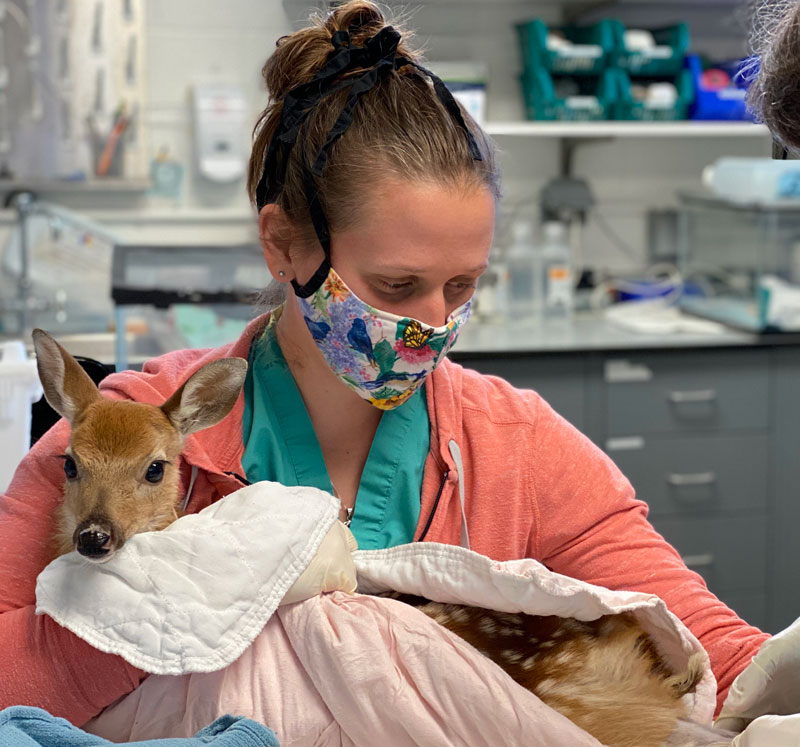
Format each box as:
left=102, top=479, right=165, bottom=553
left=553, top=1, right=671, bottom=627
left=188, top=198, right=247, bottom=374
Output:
left=387, top=592, right=708, bottom=747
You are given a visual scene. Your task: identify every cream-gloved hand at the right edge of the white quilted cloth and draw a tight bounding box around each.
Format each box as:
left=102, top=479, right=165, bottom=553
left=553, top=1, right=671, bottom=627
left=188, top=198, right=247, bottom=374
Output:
left=281, top=521, right=358, bottom=605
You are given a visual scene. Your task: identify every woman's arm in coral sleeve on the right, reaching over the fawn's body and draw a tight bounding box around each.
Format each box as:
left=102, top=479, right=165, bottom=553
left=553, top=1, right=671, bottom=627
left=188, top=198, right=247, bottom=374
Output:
left=533, top=402, right=769, bottom=709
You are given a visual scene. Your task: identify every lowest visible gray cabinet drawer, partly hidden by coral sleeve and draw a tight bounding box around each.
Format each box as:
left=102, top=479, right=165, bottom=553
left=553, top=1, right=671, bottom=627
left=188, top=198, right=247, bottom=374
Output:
left=652, top=516, right=767, bottom=596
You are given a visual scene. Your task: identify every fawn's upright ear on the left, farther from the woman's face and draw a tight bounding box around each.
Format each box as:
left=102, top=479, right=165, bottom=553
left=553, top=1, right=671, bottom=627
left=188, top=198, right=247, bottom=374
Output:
left=33, top=329, right=101, bottom=424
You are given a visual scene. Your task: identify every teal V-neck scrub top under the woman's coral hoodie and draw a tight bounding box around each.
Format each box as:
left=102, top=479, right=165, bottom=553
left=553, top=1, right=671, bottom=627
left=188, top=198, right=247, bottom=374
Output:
left=242, top=314, right=430, bottom=550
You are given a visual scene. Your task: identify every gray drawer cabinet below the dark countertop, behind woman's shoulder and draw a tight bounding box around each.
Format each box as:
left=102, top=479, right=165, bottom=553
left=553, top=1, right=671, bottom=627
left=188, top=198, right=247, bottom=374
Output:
left=453, top=345, right=800, bottom=632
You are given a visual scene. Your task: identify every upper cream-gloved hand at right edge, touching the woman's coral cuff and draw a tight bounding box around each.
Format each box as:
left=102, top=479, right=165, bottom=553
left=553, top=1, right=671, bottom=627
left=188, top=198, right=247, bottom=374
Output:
left=716, top=619, right=800, bottom=732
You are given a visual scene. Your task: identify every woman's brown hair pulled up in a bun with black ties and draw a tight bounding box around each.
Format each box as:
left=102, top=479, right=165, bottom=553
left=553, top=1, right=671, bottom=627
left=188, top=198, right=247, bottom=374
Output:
left=247, top=0, right=499, bottom=243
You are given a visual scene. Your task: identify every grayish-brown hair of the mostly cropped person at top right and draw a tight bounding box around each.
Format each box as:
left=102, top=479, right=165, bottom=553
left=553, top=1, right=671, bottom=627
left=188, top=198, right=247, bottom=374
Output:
left=748, top=0, right=800, bottom=150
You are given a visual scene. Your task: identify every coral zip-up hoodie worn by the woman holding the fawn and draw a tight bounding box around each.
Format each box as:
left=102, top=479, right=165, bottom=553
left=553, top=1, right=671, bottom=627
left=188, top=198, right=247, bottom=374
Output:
left=0, top=316, right=768, bottom=725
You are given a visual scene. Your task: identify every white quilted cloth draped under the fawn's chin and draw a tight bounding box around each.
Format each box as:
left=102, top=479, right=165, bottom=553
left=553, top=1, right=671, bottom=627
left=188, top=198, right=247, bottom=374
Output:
left=36, top=482, right=339, bottom=674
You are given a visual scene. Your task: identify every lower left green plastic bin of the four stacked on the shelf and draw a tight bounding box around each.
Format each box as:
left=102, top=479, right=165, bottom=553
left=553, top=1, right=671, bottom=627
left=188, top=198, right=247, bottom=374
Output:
left=521, top=68, right=617, bottom=122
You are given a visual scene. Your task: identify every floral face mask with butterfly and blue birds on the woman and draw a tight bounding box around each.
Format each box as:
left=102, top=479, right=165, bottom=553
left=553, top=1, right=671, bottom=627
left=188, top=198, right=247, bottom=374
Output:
left=297, top=268, right=472, bottom=410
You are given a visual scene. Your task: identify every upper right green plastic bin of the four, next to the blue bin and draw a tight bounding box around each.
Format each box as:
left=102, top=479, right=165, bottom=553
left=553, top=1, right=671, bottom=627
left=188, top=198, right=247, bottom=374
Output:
left=609, top=21, right=689, bottom=77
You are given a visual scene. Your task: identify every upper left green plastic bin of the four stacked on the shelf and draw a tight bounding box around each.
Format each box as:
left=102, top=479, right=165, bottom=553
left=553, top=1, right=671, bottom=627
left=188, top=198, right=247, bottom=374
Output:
left=516, top=18, right=614, bottom=75
